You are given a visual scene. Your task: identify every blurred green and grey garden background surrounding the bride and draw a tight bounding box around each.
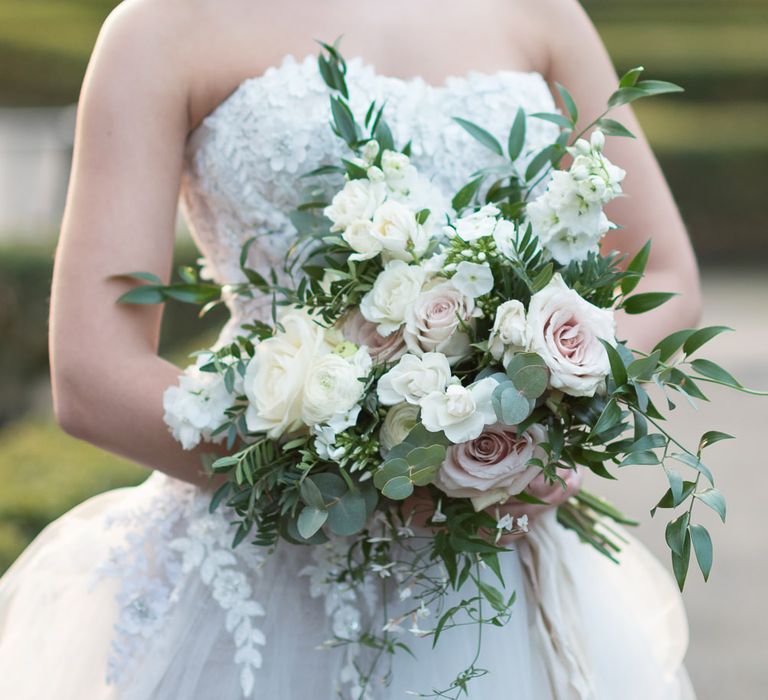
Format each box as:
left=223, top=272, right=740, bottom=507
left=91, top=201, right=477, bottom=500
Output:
left=0, top=0, right=768, bottom=700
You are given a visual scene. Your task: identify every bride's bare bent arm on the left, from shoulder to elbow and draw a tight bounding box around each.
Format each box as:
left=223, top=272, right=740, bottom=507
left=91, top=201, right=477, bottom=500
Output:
left=50, top=4, right=216, bottom=483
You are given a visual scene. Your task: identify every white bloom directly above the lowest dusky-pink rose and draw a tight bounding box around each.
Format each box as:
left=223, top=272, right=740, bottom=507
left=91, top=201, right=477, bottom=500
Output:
left=421, top=377, right=498, bottom=444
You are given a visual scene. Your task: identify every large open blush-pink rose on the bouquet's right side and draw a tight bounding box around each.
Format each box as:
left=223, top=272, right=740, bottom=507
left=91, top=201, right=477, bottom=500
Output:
left=526, top=274, right=616, bottom=396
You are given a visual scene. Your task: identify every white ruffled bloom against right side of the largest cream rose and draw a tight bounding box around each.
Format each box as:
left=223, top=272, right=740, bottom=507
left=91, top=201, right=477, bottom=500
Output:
left=301, top=349, right=371, bottom=426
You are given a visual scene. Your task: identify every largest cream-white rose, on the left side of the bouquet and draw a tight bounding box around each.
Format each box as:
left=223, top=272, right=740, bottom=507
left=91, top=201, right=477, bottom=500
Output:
left=245, top=311, right=331, bottom=439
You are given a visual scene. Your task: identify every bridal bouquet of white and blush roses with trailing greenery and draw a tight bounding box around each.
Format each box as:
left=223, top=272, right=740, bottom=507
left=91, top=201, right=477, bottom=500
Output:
left=124, top=45, right=760, bottom=697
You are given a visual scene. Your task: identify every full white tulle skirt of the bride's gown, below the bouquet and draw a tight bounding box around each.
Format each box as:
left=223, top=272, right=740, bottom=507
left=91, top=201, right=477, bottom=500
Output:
left=0, top=473, right=694, bottom=700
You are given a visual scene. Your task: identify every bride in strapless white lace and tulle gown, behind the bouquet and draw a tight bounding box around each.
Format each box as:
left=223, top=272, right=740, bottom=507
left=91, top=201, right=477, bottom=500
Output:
left=0, top=0, right=699, bottom=700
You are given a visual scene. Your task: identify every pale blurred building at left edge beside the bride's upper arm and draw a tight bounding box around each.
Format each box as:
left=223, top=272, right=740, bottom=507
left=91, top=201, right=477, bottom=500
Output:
left=0, top=106, right=75, bottom=240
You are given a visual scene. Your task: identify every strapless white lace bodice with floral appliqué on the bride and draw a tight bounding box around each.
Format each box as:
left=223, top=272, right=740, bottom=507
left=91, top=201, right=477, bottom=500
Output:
left=182, top=56, right=556, bottom=317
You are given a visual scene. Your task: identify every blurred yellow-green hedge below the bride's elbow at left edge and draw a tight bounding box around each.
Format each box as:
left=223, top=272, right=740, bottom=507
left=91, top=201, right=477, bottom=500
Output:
left=0, top=421, right=147, bottom=573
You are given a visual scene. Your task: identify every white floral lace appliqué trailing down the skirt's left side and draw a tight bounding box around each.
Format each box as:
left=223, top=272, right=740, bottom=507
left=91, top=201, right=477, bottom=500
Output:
left=98, top=477, right=266, bottom=697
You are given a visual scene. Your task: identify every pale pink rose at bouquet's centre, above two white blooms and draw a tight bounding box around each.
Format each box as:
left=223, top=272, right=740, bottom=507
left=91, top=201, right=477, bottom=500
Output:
left=403, top=281, right=478, bottom=363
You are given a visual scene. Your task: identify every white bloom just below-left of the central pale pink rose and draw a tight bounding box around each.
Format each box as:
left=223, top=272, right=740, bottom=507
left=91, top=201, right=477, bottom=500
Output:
left=377, top=352, right=451, bottom=406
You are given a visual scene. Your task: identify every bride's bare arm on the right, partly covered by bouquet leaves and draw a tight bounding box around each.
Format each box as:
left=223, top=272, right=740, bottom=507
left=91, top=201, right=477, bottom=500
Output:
left=526, top=0, right=701, bottom=350
